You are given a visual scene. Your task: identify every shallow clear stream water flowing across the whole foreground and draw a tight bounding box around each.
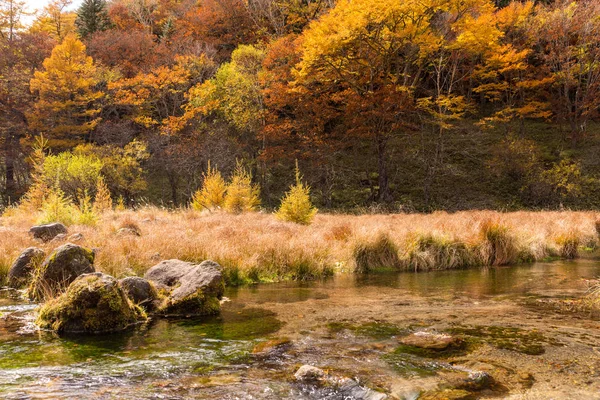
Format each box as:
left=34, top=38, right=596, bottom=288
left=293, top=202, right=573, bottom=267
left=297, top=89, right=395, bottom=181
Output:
left=0, top=260, right=600, bottom=399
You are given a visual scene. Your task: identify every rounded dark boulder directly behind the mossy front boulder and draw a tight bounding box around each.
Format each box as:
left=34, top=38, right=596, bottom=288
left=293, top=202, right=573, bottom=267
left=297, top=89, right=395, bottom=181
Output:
left=29, top=243, right=95, bottom=300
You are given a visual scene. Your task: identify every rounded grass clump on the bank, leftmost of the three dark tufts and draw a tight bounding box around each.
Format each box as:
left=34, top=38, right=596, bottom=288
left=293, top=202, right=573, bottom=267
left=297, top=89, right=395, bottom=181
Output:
left=352, top=233, right=401, bottom=274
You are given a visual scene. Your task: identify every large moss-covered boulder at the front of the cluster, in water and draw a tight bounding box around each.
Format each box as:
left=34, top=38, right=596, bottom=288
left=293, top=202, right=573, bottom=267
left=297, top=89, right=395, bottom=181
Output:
left=36, top=272, right=147, bottom=333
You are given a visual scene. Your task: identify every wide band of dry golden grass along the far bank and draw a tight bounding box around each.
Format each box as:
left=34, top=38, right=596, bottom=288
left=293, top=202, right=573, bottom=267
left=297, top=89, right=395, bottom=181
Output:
left=0, top=207, right=598, bottom=284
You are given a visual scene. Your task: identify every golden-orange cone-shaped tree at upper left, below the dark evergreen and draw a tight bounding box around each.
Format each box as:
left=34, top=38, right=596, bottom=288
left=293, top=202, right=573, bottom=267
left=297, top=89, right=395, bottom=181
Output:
left=30, top=34, right=104, bottom=145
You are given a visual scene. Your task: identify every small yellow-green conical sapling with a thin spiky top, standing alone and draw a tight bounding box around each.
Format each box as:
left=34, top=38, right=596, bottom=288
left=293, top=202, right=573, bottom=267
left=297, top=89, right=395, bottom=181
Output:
left=275, top=160, right=317, bottom=225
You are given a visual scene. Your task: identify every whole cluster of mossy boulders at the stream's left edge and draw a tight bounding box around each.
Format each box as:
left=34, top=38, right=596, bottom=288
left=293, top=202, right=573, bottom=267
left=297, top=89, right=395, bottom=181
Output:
left=9, top=233, right=225, bottom=333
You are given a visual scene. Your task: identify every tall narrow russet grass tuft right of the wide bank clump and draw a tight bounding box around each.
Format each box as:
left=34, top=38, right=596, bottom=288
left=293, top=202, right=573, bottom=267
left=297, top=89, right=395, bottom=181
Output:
left=479, top=220, right=519, bottom=265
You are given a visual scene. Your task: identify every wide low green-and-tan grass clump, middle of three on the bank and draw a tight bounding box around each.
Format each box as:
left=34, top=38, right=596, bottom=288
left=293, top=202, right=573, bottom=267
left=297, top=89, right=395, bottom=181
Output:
left=405, top=234, right=477, bottom=272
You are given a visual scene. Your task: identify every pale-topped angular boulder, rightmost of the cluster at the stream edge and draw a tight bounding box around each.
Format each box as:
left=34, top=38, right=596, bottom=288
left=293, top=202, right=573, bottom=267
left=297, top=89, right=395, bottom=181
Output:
left=144, top=260, right=225, bottom=316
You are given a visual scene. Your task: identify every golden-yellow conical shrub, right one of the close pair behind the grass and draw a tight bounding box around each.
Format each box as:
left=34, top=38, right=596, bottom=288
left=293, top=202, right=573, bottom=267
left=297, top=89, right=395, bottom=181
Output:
left=224, top=163, right=260, bottom=214
